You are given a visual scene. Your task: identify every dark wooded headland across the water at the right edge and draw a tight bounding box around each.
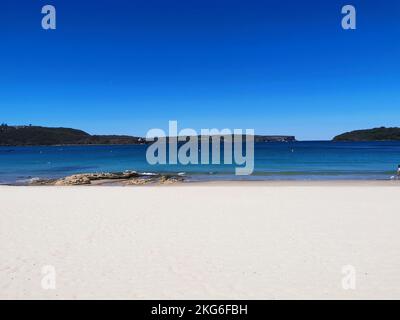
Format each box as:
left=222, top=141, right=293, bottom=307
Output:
left=333, top=127, right=400, bottom=141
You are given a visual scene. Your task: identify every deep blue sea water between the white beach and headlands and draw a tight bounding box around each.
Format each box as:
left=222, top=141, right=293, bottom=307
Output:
left=0, top=141, right=400, bottom=184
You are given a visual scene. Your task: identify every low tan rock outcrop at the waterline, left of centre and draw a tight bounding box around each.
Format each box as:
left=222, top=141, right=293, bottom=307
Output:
left=30, top=171, right=184, bottom=186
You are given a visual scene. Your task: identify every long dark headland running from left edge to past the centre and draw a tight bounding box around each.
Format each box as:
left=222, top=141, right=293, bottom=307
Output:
left=0, top=124, right=296, bottom=146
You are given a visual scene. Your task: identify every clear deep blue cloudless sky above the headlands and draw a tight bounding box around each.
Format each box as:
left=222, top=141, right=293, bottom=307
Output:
left=0, top=0, right=400, bottom=139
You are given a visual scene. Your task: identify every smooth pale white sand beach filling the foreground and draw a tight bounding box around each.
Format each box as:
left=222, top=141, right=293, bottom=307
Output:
left=0, top=181, right=400, bottom=299
